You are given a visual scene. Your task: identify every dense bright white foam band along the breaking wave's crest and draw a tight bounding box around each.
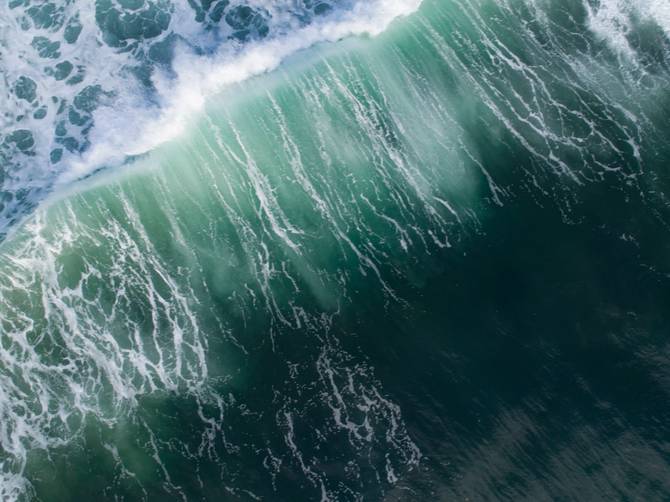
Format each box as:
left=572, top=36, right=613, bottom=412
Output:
left=58, top=0, right=421, bottom=184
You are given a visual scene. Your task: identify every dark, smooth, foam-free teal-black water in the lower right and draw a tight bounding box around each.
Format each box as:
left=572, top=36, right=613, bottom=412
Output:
left=361, top=168, right=670, bottom=500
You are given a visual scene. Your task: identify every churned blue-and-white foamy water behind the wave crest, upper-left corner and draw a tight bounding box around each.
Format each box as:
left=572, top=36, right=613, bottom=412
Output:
left=0, top=0, right=421, bottom=236
